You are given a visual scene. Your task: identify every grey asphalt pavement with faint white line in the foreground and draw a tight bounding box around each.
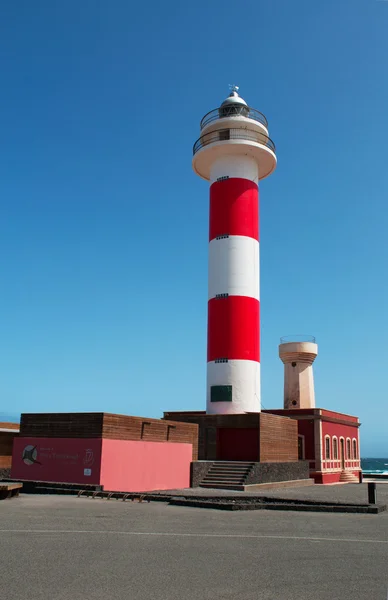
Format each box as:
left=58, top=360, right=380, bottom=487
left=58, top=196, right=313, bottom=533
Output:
left=0, top=486, right=388, bottom=600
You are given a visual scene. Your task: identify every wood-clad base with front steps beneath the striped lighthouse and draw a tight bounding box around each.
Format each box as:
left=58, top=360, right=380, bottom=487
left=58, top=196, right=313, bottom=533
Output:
left=164, top=412, right=311, bottom=491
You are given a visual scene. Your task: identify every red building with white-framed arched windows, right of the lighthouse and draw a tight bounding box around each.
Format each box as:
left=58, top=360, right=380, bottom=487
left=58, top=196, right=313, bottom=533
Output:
left=263, top=408, right=361, bottom=483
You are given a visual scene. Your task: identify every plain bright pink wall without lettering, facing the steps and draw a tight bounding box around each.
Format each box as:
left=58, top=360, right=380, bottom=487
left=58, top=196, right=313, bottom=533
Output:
left=100, top=439, right=192, bottom=492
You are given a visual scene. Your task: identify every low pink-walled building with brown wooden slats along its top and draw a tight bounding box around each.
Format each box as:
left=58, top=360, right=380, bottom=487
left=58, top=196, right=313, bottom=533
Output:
left=11, top=413, right=198, bottom=492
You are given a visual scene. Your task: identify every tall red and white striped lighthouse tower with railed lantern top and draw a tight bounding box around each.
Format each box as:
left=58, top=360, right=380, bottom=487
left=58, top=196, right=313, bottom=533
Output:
left=193, top=86, right=276, bottom=414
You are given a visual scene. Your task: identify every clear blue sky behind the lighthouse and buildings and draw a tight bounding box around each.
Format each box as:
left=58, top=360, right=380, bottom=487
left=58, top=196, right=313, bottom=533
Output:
left=0, top=0, right=388, bottom=456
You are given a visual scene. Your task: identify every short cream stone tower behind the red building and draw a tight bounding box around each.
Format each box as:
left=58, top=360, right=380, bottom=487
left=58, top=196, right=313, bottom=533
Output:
left=279, top=336, right=318, bottom=408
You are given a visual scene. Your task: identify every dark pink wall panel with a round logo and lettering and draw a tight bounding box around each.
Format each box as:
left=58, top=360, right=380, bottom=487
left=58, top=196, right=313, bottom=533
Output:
left=11, top=437, right=102, bottom=485
